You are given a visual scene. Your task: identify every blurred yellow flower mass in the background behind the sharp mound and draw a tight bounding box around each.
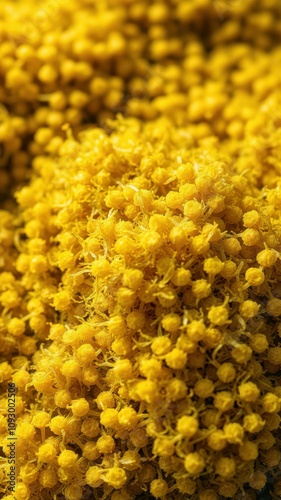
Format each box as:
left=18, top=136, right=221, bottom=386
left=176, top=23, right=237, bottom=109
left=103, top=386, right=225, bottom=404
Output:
left=0, top=0, right=281, bottom=192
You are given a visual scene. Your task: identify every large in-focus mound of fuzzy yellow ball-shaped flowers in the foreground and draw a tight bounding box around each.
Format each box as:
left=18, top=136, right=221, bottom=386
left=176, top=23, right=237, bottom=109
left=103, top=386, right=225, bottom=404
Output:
left=0, top=117, right=281, bottom=500
